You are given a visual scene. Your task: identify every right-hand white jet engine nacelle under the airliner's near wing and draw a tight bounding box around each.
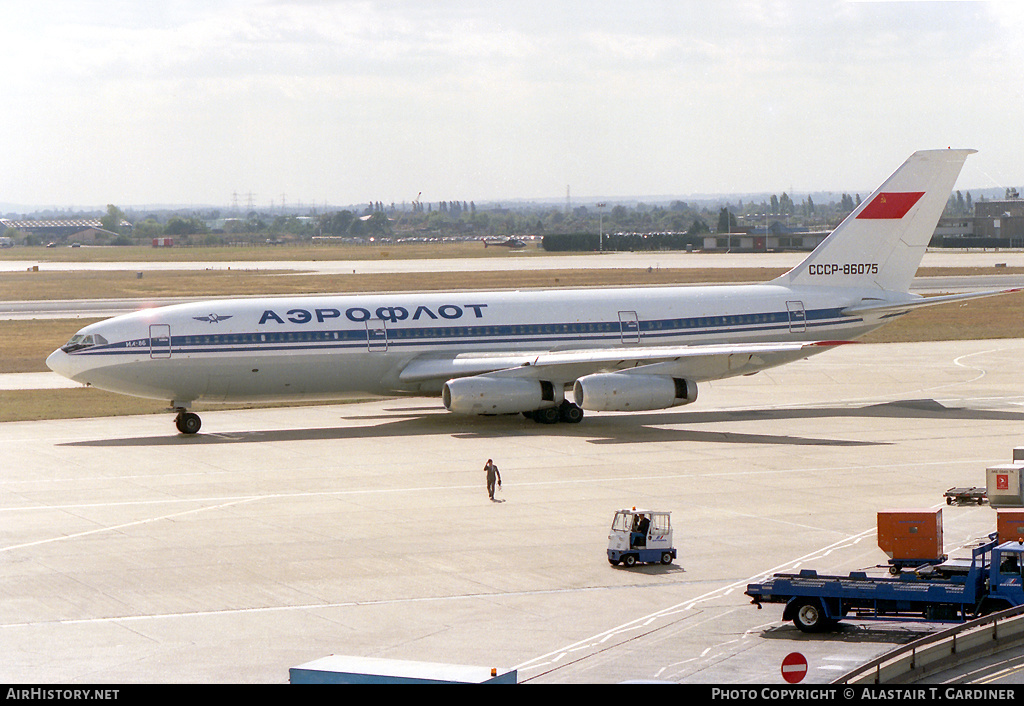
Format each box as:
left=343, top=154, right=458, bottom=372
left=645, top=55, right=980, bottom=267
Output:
left=572, top=373, right=697, bottom=412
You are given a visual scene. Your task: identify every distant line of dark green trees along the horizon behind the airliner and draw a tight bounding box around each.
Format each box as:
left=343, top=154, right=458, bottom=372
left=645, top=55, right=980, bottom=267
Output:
left=0, top=190, right=991, bottom=247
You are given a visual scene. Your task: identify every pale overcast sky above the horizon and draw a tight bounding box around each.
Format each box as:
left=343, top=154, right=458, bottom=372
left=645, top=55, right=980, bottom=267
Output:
left=0, top=0, right=1024, bottom=207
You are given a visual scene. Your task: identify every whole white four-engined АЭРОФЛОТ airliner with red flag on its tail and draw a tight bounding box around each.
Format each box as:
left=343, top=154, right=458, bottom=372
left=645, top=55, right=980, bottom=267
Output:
left=46, top=150, right=1015, bottom=434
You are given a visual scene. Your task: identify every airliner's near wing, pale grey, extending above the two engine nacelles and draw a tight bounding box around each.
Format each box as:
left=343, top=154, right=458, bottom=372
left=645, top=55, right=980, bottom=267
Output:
left=398, top=341, right=851, bottom=383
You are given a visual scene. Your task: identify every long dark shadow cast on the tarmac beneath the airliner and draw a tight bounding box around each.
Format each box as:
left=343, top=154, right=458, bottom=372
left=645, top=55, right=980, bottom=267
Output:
left=61, top=400, right=1024, bottom=447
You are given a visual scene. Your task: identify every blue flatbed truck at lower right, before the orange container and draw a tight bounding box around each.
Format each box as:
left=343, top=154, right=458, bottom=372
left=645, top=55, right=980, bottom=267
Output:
left=745, top=535, right=1024, bottom=632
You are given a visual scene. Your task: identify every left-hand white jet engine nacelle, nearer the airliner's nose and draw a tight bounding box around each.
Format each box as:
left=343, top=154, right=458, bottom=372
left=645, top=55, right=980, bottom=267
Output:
left=441, top=375, right=555, bottom=414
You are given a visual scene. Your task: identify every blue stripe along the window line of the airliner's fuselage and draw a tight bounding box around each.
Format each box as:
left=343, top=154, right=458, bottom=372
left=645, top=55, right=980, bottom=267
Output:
left=72, top=308, right=863, bottom=356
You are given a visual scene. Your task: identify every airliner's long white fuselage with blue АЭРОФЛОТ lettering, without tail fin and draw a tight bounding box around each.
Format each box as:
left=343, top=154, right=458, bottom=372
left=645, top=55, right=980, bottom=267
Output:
left=47, top=284, right=907, bottom=406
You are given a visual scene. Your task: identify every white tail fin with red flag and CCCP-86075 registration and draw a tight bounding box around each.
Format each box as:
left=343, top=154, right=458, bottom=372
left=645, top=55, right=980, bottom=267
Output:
left=775, top=150, right=976, bottom=292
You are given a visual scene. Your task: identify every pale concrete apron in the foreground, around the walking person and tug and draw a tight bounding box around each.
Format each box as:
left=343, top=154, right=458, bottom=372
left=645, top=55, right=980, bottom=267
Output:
left=0, top=340, right=1024, bottom=684
